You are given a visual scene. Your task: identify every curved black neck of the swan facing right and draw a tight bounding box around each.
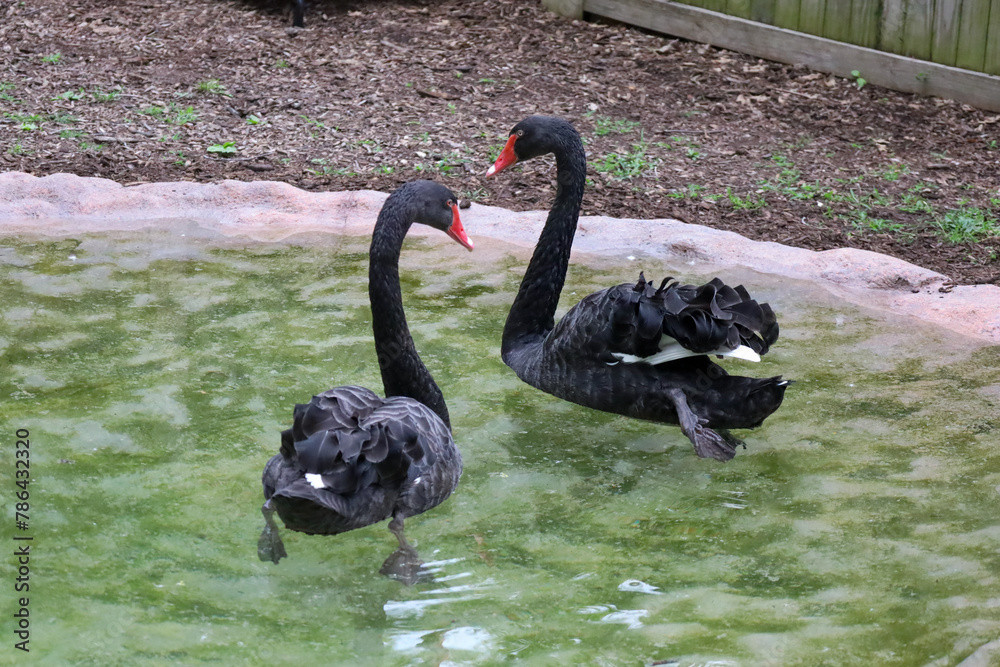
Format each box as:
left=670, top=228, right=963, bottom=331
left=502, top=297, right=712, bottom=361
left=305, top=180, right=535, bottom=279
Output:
left=368, top=197, right=451, bottom=429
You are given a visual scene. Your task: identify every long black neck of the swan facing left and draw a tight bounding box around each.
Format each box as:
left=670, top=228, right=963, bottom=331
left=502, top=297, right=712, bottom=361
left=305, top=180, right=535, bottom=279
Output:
left=502, top=131, right=587, bottom=359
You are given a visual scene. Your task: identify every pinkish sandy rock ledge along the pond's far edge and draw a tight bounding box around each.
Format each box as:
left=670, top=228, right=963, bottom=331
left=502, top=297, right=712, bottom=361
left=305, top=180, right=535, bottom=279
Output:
left=0, top=172, right=1000, bottom=345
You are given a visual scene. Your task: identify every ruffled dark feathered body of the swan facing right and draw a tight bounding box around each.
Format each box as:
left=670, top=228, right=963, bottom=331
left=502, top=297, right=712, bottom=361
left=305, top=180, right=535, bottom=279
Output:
left=263, top=386, right=462, bottom=534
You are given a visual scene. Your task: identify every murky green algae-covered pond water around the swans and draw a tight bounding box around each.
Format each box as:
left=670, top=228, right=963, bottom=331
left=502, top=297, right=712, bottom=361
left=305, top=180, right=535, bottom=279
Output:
left=0, top=226, right=1000, bottom=667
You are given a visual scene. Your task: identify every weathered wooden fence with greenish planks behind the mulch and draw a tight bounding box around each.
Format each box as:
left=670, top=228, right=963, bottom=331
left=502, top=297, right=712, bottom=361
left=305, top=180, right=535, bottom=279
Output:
left=542, top=0, right=1000, bottom=111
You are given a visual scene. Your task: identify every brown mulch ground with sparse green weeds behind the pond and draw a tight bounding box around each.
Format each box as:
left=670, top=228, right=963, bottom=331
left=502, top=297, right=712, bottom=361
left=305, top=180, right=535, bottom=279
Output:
left=0, top=0, right=1000, bottom=284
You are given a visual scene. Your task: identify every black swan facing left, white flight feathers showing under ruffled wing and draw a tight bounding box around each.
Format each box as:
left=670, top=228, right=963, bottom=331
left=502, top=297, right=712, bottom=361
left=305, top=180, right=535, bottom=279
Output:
left=486, top=116, right=788, bottom=461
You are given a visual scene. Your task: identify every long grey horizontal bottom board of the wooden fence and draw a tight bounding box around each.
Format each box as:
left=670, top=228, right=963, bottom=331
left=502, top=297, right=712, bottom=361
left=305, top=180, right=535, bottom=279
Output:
left=583, top=0, right=1000, bottom=111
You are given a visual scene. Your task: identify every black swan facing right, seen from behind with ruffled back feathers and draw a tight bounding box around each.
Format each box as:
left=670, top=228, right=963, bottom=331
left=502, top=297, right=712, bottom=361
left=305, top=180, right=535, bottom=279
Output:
left=257, top=181, right=472, bottom=580
